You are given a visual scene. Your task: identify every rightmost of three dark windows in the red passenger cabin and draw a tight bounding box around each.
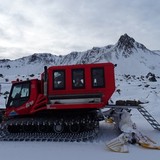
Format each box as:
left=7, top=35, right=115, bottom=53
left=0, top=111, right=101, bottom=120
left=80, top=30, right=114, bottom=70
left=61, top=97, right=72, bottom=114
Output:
left=91, top=68, right=105, bottom=88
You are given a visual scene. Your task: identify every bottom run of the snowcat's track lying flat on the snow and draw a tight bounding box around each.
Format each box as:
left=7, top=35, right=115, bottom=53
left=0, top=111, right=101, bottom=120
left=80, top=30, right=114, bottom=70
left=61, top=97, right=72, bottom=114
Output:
left=0, top=130, right=97, bottom=142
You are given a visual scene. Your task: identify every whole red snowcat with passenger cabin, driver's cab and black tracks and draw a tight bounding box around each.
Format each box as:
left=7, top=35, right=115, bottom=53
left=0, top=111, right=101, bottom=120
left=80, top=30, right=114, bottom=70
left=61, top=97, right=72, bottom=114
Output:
left=0, top=63, right=115, bottom=141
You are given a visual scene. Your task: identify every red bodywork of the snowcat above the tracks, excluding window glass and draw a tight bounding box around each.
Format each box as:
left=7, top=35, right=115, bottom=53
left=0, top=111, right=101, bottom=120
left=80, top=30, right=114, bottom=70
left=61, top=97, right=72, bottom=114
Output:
left=6, top=63, right=115, bottom=116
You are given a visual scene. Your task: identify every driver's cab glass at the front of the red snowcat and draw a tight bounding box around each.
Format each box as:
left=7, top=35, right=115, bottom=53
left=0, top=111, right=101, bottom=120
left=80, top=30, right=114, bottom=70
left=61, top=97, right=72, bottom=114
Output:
left=7, top=82, right=30, bottom=107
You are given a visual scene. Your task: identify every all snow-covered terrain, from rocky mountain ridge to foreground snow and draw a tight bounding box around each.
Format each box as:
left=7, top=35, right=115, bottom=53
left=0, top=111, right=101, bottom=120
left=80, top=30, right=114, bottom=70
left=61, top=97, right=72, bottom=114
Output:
left=0, top=34, right=160, bottom=160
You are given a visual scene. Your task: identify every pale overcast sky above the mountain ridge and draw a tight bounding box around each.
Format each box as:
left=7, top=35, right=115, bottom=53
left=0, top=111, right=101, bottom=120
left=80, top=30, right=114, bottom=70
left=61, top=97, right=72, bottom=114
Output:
left=0, top=0, right=160, bottom=59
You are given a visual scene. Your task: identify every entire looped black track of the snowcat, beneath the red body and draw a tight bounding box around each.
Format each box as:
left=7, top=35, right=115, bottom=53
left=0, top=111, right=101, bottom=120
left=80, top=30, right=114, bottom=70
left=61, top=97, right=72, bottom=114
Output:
left=0, top=113, right=99, bottom=142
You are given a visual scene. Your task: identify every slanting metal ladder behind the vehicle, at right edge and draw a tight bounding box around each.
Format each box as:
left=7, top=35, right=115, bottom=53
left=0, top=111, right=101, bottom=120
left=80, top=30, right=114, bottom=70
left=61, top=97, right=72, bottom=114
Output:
left=137, top=106, right=160, bottom=131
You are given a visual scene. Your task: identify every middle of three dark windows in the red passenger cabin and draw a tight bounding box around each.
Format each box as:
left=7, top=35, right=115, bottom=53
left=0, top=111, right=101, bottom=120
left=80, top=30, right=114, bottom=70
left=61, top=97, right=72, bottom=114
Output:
left=72, top=69, right=85, bottom=89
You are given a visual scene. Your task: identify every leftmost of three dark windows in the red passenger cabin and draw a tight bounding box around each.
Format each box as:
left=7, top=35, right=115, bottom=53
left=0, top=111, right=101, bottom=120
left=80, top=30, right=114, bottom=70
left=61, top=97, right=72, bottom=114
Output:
left=53, top=70, right=65, bottom=89
